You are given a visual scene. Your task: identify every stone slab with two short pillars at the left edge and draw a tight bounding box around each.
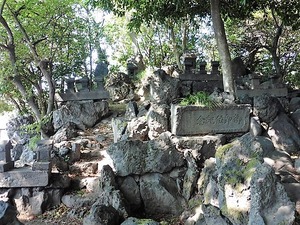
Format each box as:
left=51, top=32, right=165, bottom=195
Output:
left=0, top=141, right=53, bottom=188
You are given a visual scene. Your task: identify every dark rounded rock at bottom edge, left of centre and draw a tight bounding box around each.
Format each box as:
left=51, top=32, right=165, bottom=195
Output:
left=83, top=204, right=120, bottom=225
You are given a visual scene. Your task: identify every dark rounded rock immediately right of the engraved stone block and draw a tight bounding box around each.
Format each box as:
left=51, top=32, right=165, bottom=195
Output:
left=253, top=94, right=284, bottom=123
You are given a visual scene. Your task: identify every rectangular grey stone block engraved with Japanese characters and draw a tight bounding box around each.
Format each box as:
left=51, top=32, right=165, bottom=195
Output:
left=171, top=105, right=251, bottom=136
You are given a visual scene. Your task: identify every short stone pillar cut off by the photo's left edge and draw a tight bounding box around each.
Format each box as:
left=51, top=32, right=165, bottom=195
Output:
left=0, top=140, right=14, bottom=173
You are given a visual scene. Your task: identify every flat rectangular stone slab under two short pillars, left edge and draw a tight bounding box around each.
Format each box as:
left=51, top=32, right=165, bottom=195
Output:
left=0, top=167, right=50, bottom=188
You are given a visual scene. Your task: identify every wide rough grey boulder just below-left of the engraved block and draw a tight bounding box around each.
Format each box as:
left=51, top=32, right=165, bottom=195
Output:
left=108, top=140, right=184, bottom=176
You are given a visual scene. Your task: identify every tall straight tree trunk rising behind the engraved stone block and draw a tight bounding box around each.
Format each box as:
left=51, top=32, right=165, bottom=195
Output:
left=210, top=0, right=235, bottom=96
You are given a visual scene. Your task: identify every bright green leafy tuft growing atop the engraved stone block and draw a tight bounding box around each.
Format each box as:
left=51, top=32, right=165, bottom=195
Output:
left=179, top=91, right=221, bottom=109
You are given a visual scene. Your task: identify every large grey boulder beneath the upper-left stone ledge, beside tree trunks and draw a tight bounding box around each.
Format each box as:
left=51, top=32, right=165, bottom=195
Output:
left=53, top=100, right=109, bottom=131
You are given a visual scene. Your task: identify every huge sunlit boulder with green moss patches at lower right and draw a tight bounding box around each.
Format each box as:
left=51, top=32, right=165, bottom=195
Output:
left=186, top=133, right=295, bottom=225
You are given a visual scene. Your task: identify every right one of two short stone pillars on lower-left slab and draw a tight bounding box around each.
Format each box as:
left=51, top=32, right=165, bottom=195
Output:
left=32, top=140, right=53, bottom=173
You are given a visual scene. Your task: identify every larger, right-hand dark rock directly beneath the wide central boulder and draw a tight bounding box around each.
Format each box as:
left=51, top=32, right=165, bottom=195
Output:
left=140, top=173, right=186, bottom=216
